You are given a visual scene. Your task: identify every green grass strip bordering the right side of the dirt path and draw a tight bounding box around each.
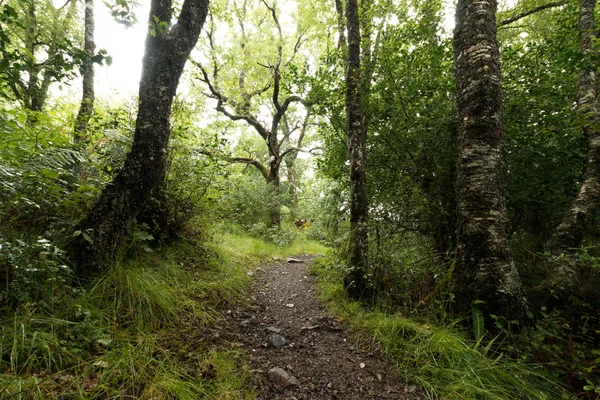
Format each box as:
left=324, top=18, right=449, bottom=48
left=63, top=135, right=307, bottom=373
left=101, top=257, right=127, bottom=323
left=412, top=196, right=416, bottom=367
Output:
left=312, top=258, right=573, bottom=400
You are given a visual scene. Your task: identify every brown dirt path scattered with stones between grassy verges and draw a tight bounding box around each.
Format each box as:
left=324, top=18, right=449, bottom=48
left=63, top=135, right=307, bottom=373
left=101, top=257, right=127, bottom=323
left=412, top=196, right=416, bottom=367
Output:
left=223, top=257, right=422, bottom=400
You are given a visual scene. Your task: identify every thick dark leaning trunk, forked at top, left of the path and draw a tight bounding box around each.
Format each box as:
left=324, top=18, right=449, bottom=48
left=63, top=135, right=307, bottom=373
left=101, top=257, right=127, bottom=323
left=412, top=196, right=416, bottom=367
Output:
left=69, top=0, right=208, bottom=273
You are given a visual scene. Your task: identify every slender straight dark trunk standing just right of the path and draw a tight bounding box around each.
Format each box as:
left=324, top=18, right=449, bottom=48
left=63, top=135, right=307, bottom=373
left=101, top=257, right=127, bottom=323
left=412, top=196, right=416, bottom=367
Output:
left=344, top=0, right=369, bottom=299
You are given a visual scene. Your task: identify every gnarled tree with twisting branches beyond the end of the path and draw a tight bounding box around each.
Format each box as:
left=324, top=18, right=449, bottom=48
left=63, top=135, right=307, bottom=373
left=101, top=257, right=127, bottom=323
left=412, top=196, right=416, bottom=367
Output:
left=196, top=0, right=311, bottom=226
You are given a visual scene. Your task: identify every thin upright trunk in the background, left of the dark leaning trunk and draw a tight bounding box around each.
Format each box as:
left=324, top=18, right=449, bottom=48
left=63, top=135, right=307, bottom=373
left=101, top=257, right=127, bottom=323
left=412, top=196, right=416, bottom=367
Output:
left=75, top=0, right=96, bottom=142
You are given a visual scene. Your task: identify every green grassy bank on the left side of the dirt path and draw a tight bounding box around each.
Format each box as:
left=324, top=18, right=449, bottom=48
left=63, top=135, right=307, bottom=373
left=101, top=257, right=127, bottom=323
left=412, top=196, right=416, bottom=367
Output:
left=0, top=230, right=326, bottom=400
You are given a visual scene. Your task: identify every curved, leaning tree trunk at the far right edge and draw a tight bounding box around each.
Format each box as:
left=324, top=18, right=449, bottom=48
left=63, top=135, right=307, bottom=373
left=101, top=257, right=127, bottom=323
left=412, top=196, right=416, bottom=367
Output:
left=547, top=0, right=600, bottom=256
